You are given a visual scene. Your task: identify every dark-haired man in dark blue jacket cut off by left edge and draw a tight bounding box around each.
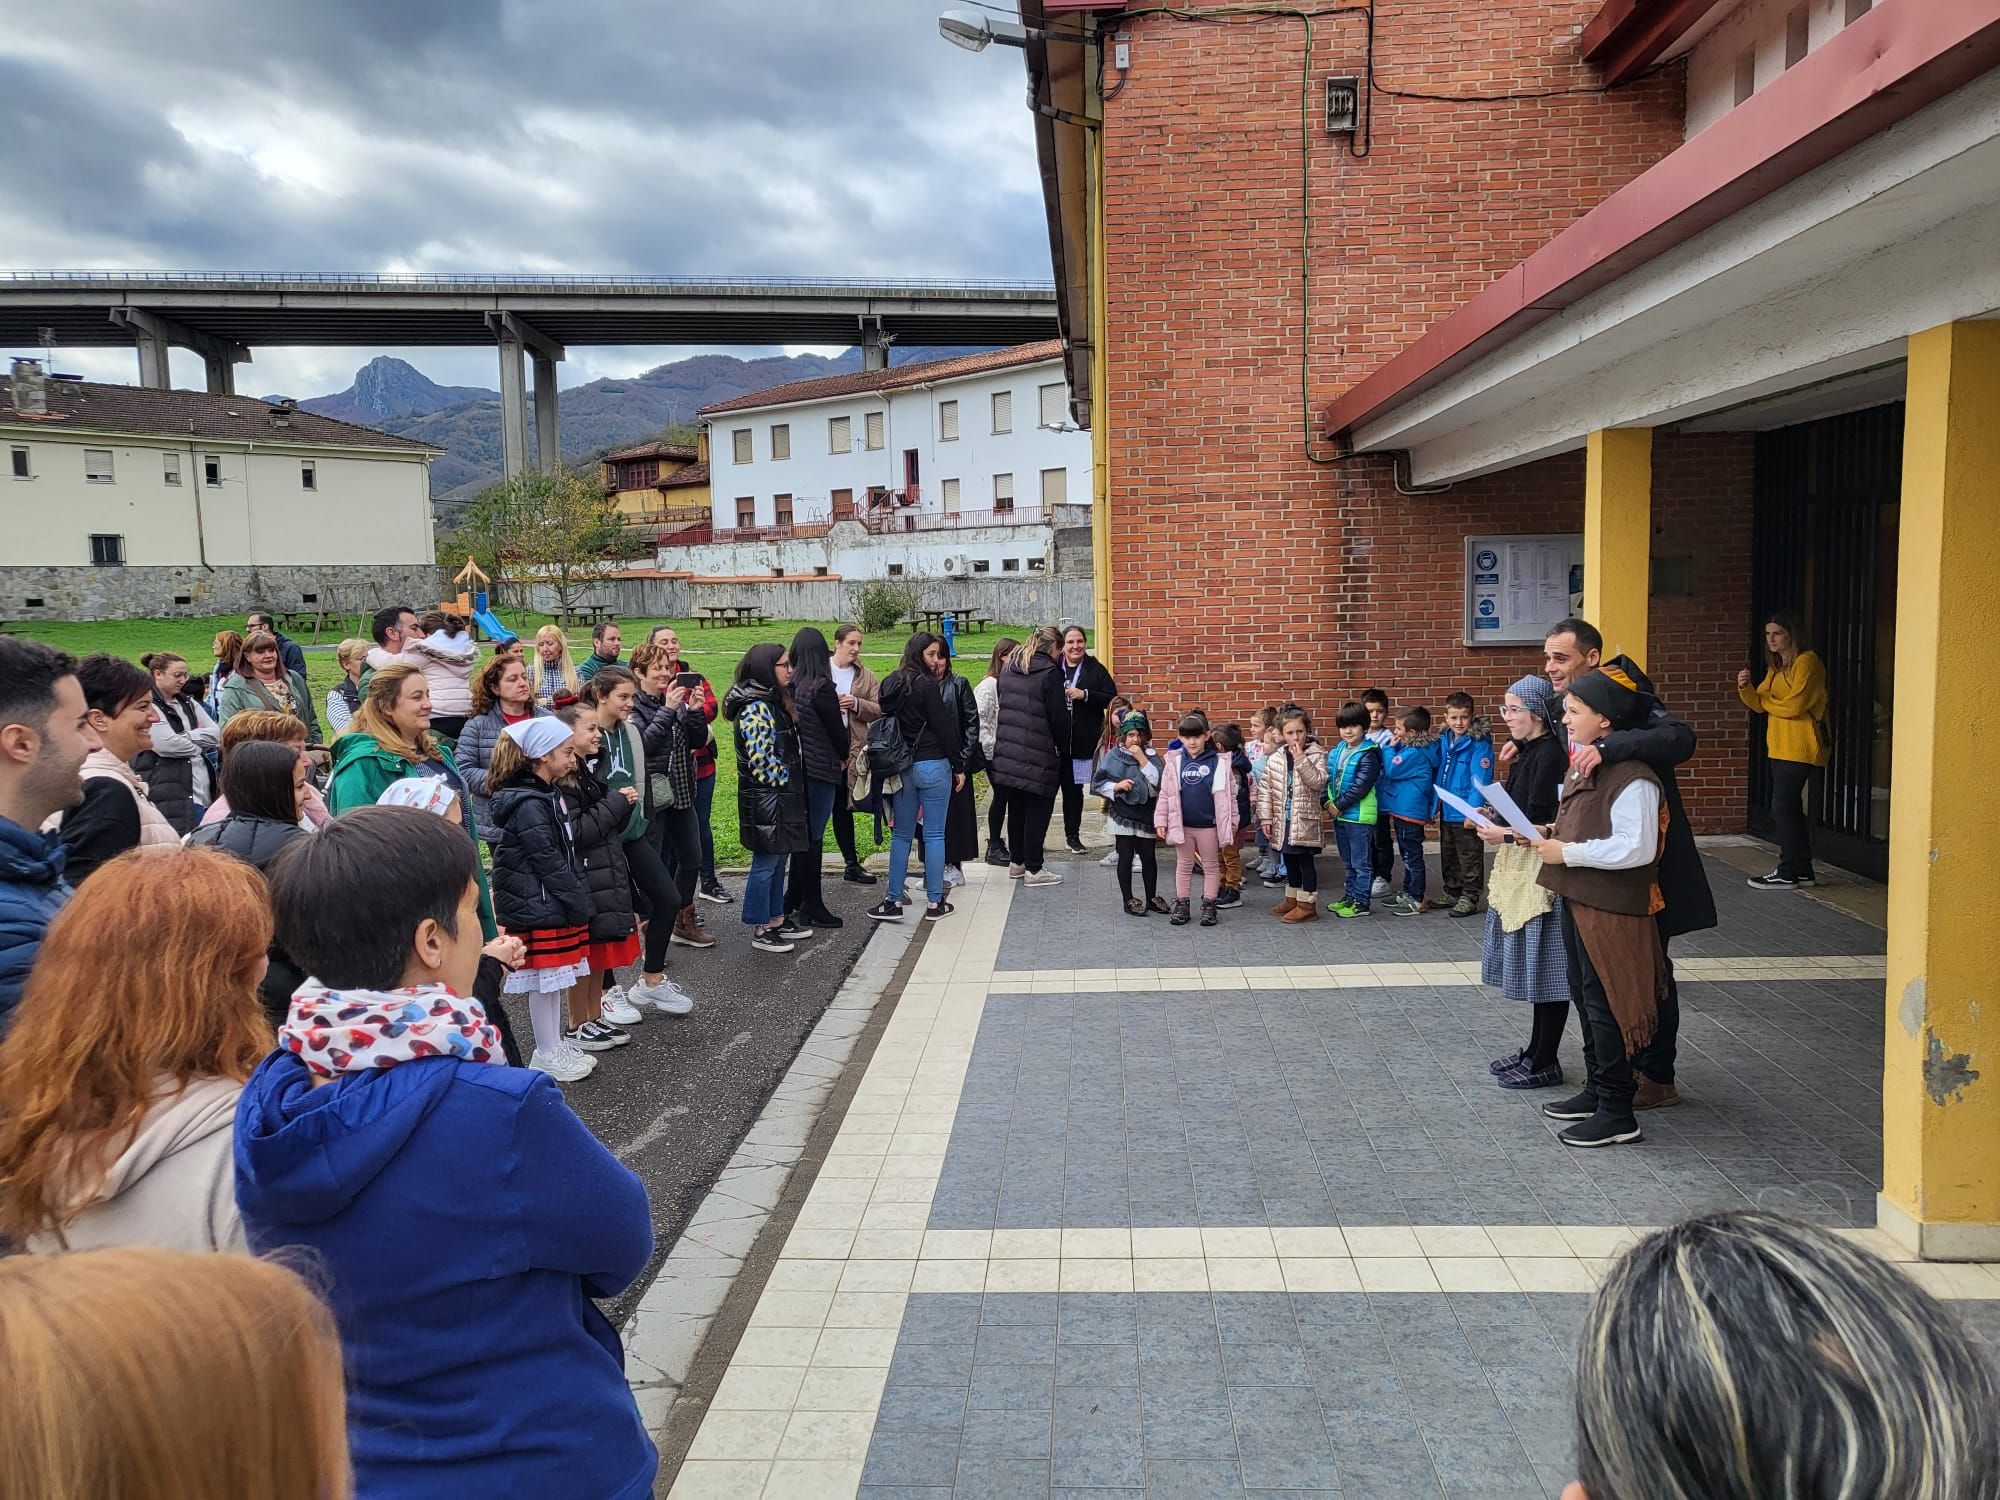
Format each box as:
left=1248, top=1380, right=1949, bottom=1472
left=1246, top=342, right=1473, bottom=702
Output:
left=0, top=636, right=98, bottom=1036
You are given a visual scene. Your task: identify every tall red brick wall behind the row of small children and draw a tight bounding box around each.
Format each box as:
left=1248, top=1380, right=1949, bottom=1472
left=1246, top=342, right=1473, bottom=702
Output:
left=1104, top=0, right=1748, bottom=828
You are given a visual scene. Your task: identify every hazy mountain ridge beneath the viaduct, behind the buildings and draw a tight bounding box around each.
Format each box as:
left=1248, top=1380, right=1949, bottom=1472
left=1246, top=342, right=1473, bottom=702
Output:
left=286, top=348, right=988, bottom=512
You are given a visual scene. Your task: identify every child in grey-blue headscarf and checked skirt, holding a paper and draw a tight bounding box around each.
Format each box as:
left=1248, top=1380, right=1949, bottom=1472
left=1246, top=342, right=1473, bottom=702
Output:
left=1476, top=676, right=1570, bottom=1088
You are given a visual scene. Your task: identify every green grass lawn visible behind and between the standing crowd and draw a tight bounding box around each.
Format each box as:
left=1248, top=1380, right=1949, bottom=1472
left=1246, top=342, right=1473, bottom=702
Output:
left=19, top=610, right=1064, bottom=866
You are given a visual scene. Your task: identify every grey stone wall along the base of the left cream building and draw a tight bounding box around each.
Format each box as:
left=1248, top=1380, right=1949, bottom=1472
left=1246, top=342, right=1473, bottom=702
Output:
left=0, top=564, right=446, bottom=622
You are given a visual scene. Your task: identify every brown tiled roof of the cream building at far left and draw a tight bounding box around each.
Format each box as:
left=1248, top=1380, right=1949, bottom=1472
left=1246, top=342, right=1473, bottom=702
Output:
left=0, top=380, right=444, bottom=454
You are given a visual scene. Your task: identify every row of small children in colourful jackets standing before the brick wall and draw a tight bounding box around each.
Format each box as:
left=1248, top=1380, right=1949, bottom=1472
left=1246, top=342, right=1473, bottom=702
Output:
left=1090, top=688, right=1494, bottom=926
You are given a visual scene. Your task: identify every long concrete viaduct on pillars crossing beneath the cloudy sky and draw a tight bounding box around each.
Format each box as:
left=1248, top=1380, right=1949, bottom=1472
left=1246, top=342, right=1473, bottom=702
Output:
left=0, top=270, right=1056, bottom=476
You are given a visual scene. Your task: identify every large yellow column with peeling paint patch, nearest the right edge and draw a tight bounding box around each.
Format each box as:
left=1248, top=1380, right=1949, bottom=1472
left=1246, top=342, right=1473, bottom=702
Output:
left=1878, top=322, right=2000, bottom=1260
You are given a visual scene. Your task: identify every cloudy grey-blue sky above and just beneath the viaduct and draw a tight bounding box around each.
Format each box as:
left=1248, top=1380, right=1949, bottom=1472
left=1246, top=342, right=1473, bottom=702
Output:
left=0, top=0, right=1050, bottom=396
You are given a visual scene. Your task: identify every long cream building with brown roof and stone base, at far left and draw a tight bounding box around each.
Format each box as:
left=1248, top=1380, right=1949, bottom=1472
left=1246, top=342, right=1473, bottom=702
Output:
left=0, top=360, right=438, bottom=620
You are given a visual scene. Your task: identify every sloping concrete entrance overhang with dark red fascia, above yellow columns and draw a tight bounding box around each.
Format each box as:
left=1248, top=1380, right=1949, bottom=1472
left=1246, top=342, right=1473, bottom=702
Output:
left=1326, top=0, right=2000, bottom=482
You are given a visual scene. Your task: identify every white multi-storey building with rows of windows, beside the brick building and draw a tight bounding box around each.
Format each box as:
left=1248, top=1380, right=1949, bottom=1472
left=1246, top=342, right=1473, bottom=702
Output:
left=702, top=340, right=1090, bottom=572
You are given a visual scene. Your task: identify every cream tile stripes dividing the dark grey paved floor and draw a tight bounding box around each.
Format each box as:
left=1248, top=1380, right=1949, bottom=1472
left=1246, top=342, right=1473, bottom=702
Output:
left=670, top=912, right=1968, bottom=1500
